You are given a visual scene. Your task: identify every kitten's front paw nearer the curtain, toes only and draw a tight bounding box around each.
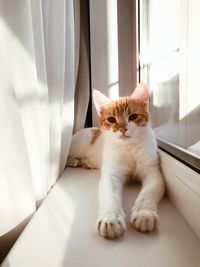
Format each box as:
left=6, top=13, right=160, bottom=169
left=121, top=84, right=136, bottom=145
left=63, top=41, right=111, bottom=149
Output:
left=96, top=213, right=126, bottom=238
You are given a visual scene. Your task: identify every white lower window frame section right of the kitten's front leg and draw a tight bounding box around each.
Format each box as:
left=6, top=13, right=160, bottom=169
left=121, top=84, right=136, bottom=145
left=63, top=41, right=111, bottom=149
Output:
left=159, top=151, right=200, bottom=240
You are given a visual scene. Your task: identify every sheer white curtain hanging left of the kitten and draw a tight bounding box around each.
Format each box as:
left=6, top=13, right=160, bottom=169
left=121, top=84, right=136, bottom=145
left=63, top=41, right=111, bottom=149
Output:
left=0, top=0, right=89, bottom=260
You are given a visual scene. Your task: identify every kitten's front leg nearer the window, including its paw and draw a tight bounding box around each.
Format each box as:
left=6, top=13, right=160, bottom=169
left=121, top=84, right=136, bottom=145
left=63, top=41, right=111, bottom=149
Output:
left=130, top=170, right=164, bottom=232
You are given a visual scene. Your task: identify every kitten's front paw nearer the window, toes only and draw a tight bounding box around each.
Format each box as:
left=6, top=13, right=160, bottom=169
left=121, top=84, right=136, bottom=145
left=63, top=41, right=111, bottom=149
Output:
left=130, top=207, right=159, bottom=232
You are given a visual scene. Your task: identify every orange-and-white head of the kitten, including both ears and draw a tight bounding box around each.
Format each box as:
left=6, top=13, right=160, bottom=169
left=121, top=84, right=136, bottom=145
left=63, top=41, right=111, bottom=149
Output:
left=93, top=84, right=150, bottom=143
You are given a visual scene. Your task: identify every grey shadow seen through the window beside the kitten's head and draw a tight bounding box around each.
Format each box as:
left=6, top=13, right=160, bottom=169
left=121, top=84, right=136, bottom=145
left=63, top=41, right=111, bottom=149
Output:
left=150, top=75, right=200, bottom=149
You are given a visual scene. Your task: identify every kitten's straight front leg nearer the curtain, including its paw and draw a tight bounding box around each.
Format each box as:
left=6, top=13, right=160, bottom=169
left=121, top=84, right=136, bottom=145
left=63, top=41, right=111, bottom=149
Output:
left=96, top=173, right=126, bottom=238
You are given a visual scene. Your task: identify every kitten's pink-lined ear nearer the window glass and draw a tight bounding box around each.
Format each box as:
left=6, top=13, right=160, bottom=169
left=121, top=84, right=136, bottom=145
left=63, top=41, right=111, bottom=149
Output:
left=131, top=83, right=149, bottom=108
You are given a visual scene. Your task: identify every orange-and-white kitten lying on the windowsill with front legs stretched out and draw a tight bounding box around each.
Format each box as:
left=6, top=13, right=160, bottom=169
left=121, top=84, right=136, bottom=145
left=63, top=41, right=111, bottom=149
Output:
left=67, top=83, right=164, bottom=238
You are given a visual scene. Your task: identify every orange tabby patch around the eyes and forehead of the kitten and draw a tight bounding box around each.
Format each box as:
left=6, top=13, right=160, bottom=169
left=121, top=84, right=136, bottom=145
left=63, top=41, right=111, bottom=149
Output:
left=99, top=97, right=150, bottom=132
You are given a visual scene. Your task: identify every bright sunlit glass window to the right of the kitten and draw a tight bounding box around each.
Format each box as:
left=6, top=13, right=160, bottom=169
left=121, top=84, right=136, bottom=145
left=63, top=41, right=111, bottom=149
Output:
left=139, top=0, right=200, bottom=171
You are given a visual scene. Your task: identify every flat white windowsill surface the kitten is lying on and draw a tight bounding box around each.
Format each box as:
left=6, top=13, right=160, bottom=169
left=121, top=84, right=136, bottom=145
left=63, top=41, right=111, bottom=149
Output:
left=2, top=169, right=200, bottom=267
